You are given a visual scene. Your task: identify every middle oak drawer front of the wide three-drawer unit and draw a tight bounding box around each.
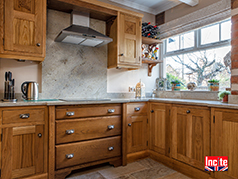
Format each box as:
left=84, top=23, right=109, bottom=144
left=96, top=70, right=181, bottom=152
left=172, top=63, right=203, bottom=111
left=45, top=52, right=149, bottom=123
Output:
left=56, top=116, right=121, bottom=144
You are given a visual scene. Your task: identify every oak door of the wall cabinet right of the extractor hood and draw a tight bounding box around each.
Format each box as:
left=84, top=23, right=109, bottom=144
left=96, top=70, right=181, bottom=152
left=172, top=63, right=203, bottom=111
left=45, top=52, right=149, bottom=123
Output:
left=119, top=13, right=141, bottom=67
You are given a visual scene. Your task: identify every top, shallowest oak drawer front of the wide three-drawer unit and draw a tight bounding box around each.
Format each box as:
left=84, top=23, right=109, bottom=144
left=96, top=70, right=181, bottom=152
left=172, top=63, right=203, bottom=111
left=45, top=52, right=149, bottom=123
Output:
left=56, top=105, right=121, bottom=119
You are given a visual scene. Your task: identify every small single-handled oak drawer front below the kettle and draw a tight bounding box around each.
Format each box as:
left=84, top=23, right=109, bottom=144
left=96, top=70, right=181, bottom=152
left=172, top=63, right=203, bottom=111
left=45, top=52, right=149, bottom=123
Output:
left=2, top=108, right=45, bottom=124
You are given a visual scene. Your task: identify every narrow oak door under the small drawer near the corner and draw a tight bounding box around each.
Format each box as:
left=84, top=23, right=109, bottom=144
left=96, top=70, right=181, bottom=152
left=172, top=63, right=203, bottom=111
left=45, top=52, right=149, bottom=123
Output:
left=127, top=116, right=147, bottom=153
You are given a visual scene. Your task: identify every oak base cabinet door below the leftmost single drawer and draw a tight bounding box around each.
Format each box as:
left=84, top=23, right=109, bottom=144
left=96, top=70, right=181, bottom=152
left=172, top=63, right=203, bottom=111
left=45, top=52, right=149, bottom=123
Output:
left=2, top=125, right=44, bottom=179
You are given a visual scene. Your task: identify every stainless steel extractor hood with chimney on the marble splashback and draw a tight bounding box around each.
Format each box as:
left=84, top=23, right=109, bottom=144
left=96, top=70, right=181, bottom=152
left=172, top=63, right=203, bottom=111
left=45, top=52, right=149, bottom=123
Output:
left=55, top=11, right=112, bottom=47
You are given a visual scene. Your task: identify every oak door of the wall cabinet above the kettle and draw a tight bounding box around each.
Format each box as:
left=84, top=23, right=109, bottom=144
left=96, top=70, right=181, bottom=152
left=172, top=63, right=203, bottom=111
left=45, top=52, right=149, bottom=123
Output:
left=4, top=0, right=46, bottom=56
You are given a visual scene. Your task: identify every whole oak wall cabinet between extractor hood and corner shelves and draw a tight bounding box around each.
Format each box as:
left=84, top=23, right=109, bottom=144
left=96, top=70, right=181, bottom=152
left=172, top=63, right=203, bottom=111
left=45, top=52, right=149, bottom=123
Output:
left=108, top=12, right=142, bottom=68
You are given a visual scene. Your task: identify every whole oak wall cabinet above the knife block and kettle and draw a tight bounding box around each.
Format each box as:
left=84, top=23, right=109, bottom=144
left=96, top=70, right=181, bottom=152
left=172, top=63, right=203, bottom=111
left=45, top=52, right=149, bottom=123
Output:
left=0, top=0, right=46, bottom=61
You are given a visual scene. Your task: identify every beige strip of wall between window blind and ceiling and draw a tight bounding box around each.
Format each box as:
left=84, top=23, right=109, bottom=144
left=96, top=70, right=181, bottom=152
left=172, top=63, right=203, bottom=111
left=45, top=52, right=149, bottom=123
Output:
left=165, top=0, right=218, bottom=23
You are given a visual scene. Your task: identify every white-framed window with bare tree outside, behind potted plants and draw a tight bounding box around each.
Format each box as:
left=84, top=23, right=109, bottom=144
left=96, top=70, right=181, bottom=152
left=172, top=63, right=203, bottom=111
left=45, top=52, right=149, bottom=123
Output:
left=163, top=19, right=231, bottom=90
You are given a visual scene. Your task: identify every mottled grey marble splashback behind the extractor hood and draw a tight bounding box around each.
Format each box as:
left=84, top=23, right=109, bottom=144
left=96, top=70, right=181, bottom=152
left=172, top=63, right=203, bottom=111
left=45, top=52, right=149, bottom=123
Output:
left=41, top=10, right=107, bottom=98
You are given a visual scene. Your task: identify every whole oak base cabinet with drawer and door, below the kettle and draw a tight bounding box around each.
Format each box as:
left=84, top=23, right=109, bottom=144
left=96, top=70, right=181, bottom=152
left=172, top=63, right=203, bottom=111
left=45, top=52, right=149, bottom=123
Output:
left=1, top=106, right=48, bottom=179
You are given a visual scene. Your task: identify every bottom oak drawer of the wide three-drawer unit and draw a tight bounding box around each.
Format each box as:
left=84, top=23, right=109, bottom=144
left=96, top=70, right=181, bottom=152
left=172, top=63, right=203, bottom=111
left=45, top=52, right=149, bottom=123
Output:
left=56, top=137, right=121, bottom=169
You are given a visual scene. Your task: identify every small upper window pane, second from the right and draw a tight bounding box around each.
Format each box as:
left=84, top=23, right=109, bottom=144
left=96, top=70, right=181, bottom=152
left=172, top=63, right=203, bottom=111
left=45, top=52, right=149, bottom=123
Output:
left=201, top=24, right=219, bottom=45
